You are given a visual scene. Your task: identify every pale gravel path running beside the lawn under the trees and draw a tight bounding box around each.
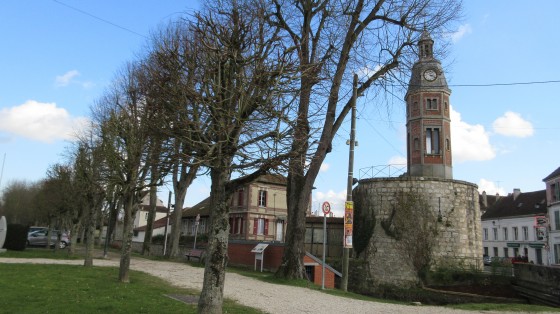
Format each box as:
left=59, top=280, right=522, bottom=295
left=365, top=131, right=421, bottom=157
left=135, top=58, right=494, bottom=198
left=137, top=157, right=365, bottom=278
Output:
left=0, top=257, right=532, bottom=314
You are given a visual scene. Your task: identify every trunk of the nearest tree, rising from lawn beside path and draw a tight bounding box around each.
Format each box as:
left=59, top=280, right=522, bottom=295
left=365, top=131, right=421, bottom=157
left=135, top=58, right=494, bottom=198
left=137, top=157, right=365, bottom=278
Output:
left=198, top=168, right=229, bottom=313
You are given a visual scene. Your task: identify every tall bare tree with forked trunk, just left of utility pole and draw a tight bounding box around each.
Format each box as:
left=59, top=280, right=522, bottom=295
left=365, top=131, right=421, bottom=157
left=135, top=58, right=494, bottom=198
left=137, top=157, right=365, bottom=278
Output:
left=269, top=0, right=460, bottom=278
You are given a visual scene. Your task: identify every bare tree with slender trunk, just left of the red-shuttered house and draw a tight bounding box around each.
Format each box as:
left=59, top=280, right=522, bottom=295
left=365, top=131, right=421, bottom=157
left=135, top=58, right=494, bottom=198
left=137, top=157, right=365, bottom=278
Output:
left=139, top=20, right=202, bottom=257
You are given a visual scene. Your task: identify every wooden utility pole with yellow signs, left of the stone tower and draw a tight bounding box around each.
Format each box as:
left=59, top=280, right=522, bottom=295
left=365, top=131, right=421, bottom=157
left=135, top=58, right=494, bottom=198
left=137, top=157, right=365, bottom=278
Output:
left=341, top=73, right=358, bottom=291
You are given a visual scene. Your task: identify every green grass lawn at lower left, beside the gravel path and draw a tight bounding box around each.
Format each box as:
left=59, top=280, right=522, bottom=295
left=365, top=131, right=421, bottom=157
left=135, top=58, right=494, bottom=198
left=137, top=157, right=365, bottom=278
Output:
left=0, top=249, right=261, bottom=313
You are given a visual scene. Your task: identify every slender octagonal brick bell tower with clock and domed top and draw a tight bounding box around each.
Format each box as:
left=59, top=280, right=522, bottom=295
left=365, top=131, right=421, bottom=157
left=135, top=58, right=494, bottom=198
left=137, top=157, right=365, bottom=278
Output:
left=405, top=30, right=453, bottom=179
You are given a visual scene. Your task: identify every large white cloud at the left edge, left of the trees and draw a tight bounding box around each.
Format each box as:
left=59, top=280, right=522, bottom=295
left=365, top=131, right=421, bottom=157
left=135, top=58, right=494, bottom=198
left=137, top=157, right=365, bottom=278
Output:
left=0, top=100, right=87, bottom=142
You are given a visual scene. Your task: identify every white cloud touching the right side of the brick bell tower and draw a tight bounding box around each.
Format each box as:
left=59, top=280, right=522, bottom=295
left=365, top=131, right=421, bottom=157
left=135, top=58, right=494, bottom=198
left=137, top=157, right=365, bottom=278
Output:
left=451, top=107, right=496, bottom=163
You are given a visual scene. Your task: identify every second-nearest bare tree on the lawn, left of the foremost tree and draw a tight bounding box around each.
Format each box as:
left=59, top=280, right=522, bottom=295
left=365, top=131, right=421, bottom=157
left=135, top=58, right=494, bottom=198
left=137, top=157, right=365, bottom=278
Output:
left=93, top=63, right=167, bottom=282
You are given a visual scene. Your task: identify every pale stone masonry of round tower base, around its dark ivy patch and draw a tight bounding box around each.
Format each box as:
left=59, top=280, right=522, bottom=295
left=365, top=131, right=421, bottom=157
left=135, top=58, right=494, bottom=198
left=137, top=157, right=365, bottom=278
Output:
left=353, top=177, right=482, bottom=287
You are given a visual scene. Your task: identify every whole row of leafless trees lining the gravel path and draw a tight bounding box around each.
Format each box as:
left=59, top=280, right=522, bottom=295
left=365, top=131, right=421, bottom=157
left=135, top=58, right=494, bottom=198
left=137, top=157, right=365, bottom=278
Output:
left=2, top=0, right=460, bottom=313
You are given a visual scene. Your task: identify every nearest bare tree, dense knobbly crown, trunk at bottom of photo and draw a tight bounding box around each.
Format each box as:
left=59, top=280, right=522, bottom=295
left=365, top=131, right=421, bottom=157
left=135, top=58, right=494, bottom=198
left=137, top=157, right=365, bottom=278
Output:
left=161, top=1, right=298, bottom=313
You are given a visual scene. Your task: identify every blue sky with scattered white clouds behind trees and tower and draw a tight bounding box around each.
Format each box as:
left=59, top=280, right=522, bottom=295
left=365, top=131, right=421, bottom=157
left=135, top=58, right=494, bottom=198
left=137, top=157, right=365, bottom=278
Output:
left=0, top=0, right=560, bottom=216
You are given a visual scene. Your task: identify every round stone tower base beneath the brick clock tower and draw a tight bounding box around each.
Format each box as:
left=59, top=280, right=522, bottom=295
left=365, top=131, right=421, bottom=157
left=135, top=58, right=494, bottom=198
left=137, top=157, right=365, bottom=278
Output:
left=351, top=177, right=483, bottom=288
